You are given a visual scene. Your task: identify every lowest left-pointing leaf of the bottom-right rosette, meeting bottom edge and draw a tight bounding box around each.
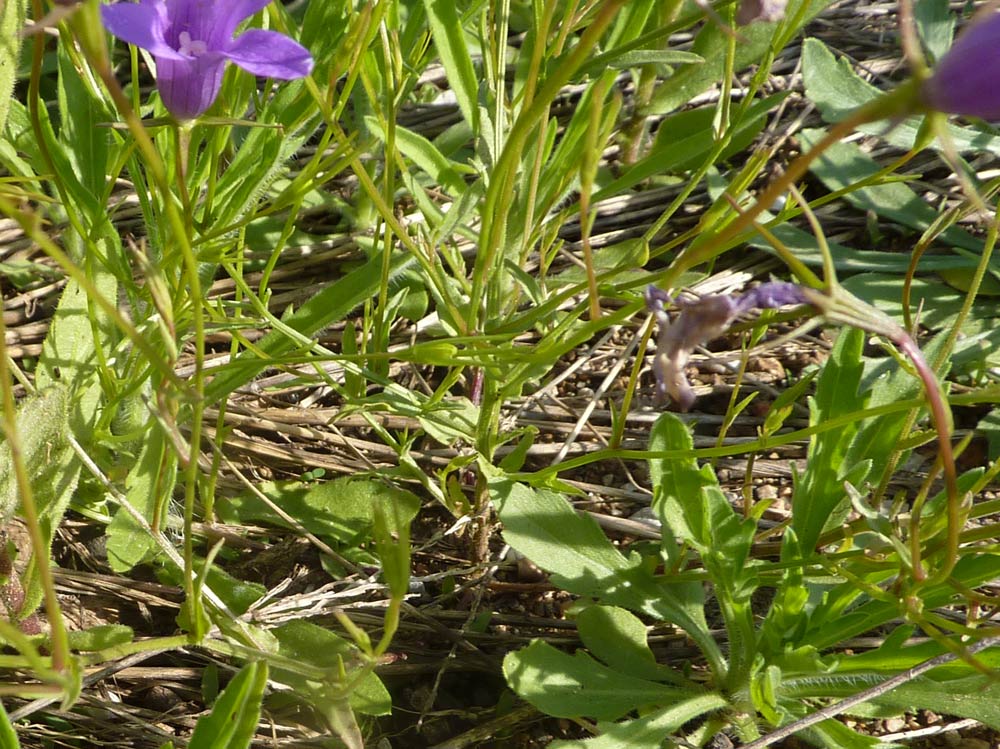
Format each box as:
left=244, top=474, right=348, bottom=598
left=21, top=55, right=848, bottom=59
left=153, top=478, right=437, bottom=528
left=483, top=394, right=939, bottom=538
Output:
left=549, top=693, right=727, bottom=749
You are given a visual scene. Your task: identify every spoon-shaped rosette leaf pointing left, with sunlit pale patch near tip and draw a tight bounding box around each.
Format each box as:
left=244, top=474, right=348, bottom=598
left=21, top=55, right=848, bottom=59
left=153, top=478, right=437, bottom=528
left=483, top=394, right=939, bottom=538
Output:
left=503, top=640, right=690, bottom=720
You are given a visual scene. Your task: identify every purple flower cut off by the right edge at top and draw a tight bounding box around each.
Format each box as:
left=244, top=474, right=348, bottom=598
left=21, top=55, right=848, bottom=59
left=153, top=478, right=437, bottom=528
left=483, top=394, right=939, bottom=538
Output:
left=923, top=12, right=1000, bottom=120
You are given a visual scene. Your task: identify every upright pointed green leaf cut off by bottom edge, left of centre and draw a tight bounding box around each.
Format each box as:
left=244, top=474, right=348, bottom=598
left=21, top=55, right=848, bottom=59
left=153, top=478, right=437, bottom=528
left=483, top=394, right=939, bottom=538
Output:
left=188, top=661, right=267, bottom=749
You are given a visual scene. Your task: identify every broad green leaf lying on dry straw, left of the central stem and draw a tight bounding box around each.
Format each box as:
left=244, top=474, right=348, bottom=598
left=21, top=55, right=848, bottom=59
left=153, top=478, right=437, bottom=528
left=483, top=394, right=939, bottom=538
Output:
left=217, top=476, right=420, bottom=545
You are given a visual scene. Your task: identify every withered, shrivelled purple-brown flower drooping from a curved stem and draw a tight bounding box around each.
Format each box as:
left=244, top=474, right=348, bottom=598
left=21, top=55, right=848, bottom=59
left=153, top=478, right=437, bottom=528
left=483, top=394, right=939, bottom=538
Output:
left=645, top=281, right=808, bottom=411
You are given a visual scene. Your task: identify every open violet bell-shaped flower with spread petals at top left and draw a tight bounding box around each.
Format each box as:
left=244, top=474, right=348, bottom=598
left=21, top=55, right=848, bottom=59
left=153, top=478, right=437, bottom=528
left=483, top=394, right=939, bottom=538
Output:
left=101, top=0, right=313, bottom=120
